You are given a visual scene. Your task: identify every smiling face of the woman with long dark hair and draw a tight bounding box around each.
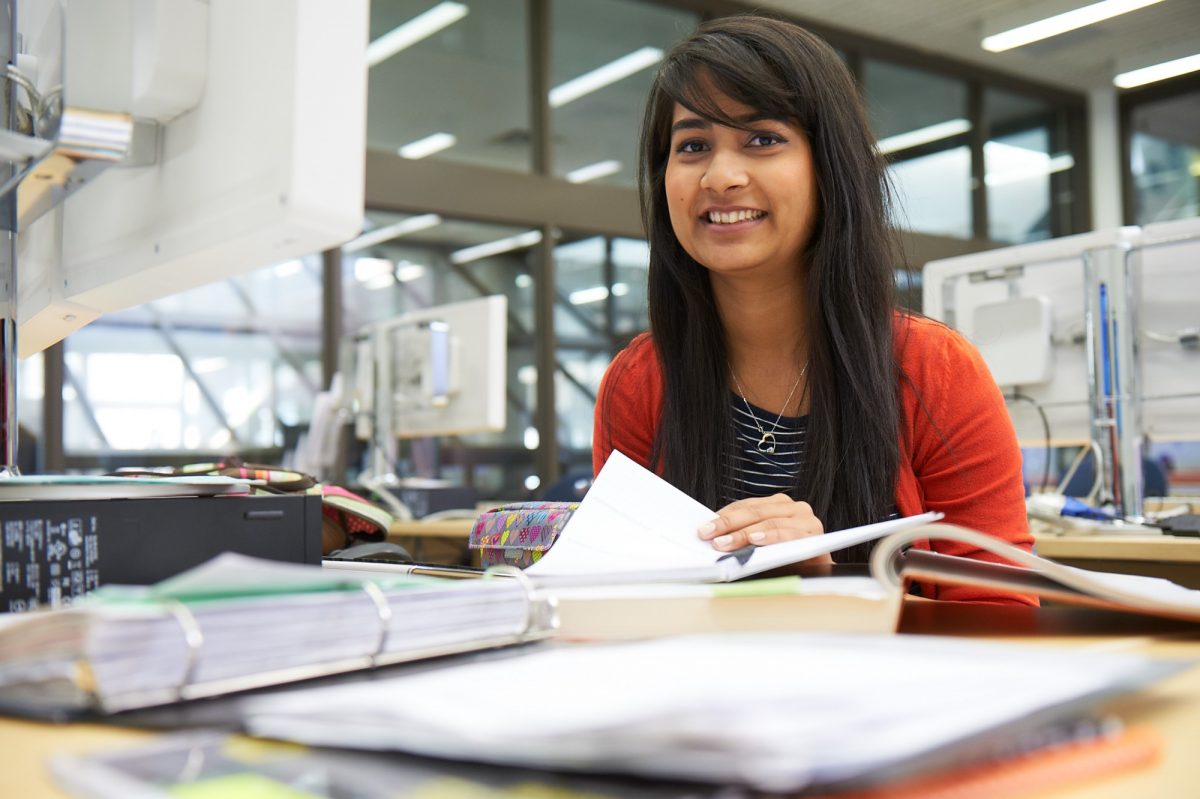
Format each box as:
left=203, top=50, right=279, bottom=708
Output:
left=666, top=95, right=817, bottom=275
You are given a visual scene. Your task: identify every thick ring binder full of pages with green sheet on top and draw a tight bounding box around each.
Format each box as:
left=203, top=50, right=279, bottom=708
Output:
left=0, top=553, right=558, bottom=715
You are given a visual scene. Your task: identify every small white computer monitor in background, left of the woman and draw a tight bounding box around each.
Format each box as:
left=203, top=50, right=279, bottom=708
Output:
left=343, top=295, right=508, bottom=479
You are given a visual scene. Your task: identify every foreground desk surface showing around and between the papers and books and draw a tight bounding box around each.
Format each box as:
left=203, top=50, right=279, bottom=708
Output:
left=0, top=596, right=1200, bottom=799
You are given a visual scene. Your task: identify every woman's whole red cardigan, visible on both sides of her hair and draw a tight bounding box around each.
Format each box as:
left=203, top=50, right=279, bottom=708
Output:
left=592, top=314, right=1037, bottom=605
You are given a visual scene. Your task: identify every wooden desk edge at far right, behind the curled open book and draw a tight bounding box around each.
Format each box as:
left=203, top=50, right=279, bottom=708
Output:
left=1033, top=533, right=1200, bottom=588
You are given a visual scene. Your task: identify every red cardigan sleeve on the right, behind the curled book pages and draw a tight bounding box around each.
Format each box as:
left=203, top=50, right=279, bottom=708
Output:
left=898, top=320, right=1037, bottom=605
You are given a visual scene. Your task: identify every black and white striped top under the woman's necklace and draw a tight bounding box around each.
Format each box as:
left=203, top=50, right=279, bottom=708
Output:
left=722, top=394, right=808, bottom=503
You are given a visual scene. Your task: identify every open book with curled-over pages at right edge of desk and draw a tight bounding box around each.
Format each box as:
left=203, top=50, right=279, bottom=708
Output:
left=871, top=524, right=1200, bottom=621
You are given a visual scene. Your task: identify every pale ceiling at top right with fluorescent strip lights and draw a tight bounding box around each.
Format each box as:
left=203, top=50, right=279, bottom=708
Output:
left=746, top=0, right=1200, bottom=90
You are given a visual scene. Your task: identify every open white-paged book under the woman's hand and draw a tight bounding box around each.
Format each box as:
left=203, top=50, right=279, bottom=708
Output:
left=524, top=450, right=942, bottom=587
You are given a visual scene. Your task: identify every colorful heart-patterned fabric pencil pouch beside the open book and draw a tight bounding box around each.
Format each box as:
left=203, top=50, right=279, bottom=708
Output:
left=469, top=503, right=580, bottom=569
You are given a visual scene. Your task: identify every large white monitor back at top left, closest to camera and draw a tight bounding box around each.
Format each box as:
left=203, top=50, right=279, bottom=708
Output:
left=18, top=0, right=368, bottom=355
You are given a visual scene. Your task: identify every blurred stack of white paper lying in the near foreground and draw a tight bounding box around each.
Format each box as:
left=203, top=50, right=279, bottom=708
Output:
left=238, top=633, right=1175, bottom=791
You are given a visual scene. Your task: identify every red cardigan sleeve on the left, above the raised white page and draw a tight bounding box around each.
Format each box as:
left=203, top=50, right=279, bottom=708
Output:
left=592, top=334, right=662, bottom=474
